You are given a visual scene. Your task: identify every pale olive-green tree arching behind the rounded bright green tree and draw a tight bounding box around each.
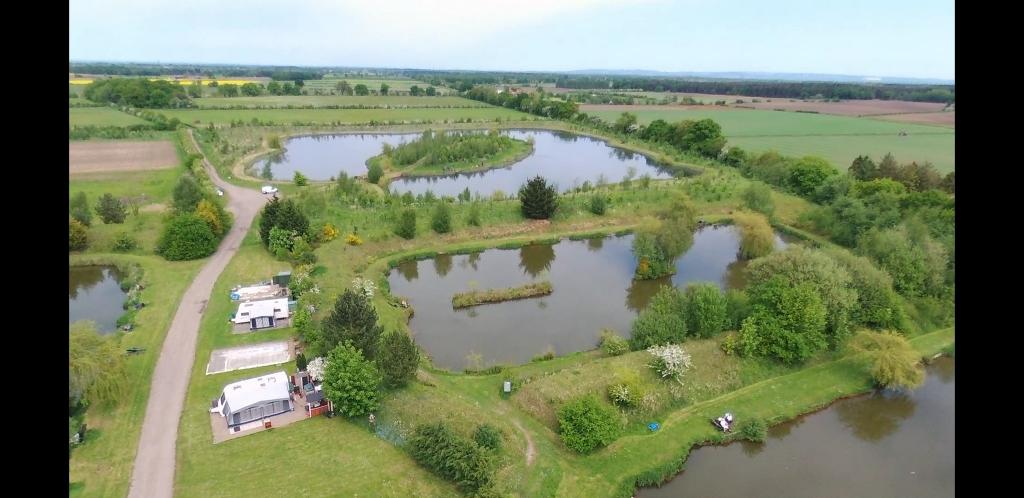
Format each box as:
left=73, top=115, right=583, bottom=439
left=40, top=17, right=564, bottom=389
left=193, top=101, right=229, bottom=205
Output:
left=746, top=246, right=857, bottom=348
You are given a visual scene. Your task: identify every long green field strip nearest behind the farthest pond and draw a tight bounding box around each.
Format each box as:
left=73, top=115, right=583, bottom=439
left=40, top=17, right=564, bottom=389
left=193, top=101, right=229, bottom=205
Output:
left=159, top=107, right=532, bottom=124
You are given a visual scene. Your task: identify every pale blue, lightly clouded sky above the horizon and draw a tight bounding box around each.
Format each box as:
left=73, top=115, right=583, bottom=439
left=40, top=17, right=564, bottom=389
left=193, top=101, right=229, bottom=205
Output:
left=69, top=0, right=955, bottom=80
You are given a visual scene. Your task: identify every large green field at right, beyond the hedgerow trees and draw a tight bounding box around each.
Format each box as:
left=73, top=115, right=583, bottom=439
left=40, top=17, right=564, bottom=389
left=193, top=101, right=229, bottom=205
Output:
left=584, top=108, right=955, bottom=172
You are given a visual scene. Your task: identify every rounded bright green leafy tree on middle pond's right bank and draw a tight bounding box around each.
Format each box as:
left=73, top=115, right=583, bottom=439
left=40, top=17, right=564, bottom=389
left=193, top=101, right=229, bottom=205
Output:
left=739, top=276, right=827, bottom=365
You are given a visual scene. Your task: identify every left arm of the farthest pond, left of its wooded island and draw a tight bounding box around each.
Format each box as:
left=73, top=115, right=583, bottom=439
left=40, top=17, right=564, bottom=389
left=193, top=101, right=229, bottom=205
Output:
left=250, top=133, right=420, bottom=180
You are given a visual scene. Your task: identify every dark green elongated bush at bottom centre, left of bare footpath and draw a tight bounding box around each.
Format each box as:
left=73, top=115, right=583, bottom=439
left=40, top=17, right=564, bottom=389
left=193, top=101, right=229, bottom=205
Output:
left=408, top=422, right=494, bottom=493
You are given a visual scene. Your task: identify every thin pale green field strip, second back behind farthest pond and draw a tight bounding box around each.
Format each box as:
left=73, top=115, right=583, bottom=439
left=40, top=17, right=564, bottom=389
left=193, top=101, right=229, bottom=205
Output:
left=194, top=95, right=489, bottom=108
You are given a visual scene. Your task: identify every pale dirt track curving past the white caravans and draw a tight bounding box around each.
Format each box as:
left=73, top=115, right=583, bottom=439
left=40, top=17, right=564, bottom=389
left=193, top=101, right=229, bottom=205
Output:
left=128, top=130, right=267, bottom=498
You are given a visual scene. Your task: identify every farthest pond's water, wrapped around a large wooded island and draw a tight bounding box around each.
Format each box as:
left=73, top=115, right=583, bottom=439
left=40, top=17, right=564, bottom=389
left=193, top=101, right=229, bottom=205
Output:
left=251, top=130, right=672, bottom=197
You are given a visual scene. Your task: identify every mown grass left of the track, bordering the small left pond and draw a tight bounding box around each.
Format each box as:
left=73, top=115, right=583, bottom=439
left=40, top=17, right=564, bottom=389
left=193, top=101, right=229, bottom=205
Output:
left=69, top=253, right=205, bottom=497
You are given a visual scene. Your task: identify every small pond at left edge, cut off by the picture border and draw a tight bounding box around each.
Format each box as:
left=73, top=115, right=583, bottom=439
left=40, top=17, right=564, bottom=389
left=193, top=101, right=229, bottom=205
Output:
left=68, top=266, right=126, bottom=332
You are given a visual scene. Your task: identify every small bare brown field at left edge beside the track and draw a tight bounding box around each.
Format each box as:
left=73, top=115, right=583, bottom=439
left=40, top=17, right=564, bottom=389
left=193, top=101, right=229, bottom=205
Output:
left=68, top=140, right=178, bottom=174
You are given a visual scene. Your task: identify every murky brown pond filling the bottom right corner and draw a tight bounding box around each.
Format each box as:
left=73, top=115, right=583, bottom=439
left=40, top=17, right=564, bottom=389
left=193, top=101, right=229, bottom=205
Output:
left=637, top=358, right=956, bottom=498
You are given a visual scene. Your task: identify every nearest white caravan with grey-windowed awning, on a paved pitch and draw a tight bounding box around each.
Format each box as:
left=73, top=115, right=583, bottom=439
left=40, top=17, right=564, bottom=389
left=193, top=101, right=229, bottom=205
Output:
left=210, top=371, right=295, bottom=427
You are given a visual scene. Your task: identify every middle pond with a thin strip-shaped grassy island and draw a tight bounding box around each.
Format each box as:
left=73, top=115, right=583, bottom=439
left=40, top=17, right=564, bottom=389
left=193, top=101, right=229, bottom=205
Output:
left=388, top=226, right=785, bottom=370
